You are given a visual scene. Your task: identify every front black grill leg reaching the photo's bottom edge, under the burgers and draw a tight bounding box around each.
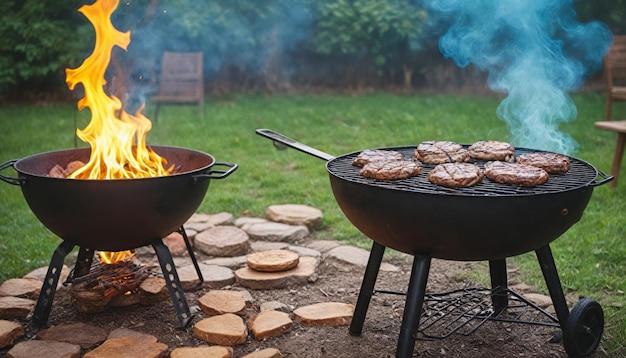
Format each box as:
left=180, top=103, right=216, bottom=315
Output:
left=396, top=255, right=431, bottom=358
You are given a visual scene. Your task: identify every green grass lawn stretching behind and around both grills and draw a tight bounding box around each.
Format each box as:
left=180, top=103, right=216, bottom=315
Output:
left=0, top=94, right=626, bottom=356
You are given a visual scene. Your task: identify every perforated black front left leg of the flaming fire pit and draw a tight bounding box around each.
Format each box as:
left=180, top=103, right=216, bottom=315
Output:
left=33, top=240, right=74, bottom=327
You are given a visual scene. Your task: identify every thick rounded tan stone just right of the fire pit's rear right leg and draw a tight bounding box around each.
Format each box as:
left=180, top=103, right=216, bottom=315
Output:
left=195, top=226, right=250, bottom=256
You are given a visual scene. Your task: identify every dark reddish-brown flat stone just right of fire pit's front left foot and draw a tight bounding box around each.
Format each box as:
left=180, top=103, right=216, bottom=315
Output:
left=37, top=323, right=107, bottom=349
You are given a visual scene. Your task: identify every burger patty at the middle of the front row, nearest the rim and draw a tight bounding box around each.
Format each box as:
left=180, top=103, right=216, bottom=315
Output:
left=428, top=163, right=484, bottom=188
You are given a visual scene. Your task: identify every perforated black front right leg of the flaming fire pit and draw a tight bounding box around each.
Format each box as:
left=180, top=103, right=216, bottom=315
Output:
left=151, top=239, right=194, bottom=328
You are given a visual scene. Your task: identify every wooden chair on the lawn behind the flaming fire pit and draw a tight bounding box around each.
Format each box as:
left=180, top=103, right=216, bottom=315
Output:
left=152, top=52, right=204, bottom=122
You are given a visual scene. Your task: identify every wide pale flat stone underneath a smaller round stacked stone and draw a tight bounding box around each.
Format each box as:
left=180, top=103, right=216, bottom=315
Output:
left=235, top=257, right=317, bottom=290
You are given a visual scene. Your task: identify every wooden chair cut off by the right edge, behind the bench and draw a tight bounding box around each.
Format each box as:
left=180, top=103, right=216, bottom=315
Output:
left=604, top=35, right=626, bottom=121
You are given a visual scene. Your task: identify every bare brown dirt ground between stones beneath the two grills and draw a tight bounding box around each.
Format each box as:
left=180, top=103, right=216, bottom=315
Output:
left=7, top=249, right=607, bottom=358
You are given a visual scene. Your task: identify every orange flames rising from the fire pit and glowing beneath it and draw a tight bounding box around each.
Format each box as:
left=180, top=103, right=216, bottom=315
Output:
left=65, top=0, right=172, bottom=263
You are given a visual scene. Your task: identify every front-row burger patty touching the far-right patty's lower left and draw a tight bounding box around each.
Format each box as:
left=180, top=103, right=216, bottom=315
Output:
left=485, top=161, right=548, bottom=187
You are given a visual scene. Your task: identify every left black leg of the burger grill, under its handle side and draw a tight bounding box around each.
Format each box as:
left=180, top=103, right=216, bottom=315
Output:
left=349, top=241, right=385, bottom=336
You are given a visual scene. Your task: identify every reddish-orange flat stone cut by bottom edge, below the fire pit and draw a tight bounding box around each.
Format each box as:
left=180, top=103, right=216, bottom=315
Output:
left=83, top=336, right=169, bottom=358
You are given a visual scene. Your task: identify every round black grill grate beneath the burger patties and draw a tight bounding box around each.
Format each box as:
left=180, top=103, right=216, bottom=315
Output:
left=326, top=145, right=598, bottom=196
